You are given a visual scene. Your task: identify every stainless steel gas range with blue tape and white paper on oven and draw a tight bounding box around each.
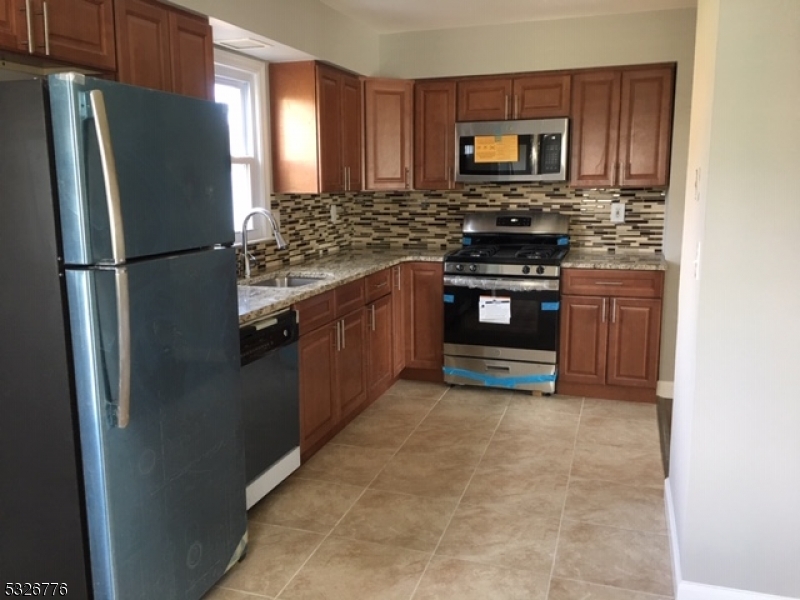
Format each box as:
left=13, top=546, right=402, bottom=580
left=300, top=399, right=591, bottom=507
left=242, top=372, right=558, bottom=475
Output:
left=444, top=211, right=569, bottom=393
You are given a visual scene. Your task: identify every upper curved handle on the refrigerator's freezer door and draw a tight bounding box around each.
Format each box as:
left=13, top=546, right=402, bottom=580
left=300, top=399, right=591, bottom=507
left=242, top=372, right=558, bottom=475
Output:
left=89, top=90, right=125, bottom=265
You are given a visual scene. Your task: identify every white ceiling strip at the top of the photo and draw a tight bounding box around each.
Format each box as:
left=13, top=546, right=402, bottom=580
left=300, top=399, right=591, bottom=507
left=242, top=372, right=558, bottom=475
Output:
left=320, top=0, right=697, bottom=33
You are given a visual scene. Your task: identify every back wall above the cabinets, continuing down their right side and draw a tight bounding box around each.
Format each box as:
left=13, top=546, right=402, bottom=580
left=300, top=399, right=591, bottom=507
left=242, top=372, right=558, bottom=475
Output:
left=380, top=9, right=695, bottom=381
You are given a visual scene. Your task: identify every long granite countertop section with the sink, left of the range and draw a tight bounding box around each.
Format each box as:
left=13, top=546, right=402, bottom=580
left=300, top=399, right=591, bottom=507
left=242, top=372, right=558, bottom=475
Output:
left=238, top=249, right=446, bottom=325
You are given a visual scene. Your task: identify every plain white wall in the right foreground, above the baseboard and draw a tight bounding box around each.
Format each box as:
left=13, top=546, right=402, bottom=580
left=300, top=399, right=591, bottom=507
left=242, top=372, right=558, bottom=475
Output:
left=670, top=0, right=800, bottom=599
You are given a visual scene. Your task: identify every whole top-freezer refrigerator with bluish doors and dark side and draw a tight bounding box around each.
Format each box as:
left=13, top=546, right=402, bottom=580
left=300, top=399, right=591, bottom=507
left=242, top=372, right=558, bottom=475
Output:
left=0, top=74, right=246, bottom=600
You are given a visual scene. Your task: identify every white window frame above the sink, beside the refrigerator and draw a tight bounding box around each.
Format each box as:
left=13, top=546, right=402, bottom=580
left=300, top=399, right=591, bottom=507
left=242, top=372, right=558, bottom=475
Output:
left=214, top=47, right=272, bottom=244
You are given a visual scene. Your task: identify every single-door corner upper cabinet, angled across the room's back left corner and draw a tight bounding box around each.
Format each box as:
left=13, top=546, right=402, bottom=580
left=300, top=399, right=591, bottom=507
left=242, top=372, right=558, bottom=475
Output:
left=364, top=79, right=414, bottom=190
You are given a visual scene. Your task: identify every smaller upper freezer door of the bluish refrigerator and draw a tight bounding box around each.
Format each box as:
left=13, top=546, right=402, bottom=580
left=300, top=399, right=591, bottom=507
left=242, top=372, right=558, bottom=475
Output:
left=48, top=73, right=233, bottom=265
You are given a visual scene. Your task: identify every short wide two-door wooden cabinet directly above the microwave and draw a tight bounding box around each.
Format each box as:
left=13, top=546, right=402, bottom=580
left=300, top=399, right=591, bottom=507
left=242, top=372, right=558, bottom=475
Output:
left=457, top=73, right=571, bottom=121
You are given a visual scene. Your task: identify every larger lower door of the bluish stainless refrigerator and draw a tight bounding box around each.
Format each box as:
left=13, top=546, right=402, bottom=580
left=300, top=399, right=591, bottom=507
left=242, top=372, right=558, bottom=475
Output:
left=67, top=248, right=246, bottom=600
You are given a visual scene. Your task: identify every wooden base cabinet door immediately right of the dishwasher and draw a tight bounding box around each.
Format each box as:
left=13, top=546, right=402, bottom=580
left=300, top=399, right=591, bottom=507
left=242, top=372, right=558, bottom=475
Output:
left=298, top=323, right=339, bottom=453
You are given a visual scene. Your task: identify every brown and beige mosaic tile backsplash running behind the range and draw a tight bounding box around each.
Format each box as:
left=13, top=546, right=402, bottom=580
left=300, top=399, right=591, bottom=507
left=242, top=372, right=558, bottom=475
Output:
left=234, top=184, right=665, bottom=277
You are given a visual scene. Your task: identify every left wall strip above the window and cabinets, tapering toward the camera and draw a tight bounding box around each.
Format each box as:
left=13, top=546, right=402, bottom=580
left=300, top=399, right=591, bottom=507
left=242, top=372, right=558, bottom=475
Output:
left=170, top=0, right=379, bottom=75
